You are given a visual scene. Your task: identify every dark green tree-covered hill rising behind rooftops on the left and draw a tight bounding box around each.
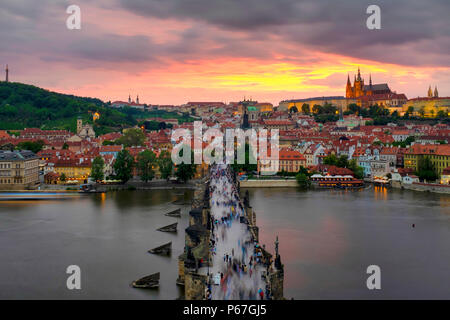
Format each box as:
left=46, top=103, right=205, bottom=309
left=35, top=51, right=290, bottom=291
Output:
left=0, top=82, right=193, bottom=134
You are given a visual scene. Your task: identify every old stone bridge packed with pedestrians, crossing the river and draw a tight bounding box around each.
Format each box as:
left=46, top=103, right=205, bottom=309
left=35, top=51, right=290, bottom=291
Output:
left=177, top=165, right=284, bottom=300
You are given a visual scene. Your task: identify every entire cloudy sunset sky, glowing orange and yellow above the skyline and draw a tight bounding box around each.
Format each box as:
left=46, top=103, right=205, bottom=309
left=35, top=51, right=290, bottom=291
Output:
left=0, top=0, right=450, bottom=105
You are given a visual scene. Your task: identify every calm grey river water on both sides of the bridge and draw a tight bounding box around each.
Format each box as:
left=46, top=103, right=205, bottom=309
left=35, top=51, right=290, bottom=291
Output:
left=0, top=188, right=450, bottom=299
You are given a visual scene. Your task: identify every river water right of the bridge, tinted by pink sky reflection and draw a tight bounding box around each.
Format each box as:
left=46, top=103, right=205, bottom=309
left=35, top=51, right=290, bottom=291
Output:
left=249, top=187, right=450, bottom=299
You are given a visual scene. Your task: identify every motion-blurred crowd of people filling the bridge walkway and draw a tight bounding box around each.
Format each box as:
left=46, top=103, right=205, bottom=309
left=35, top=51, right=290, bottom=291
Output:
left=206, top=165, right=270, bottom=300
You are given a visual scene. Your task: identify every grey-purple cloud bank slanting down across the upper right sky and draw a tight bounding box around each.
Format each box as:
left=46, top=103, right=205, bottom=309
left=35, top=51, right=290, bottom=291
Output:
left=118, top=0, right=450, bottom=65
